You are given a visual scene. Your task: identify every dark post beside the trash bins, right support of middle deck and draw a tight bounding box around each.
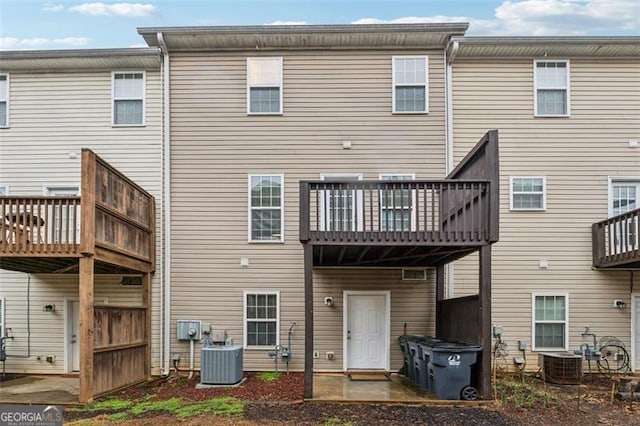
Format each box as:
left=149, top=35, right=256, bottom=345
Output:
left=478, top=245, right=493, bottom=399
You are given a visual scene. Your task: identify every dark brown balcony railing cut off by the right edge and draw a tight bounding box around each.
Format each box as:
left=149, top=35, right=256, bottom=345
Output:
left=592, top=209, right=640, bottom=268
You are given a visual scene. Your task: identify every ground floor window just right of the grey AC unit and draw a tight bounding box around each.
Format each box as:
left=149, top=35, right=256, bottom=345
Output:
left=244, top=291, right=280, bottom=348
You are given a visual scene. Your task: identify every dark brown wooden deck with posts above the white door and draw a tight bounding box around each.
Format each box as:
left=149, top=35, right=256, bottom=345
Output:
left=300, top=130, right=500, bottom=398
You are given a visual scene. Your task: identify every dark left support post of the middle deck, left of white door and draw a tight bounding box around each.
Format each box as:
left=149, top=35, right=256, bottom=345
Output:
left=303, top=244, right=313, bottom=398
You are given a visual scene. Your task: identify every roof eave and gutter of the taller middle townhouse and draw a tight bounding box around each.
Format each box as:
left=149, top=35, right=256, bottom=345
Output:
left=138, top=22, right=469, bottom=51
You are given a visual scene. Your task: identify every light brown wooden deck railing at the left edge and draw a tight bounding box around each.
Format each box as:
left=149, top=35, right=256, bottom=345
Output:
left=0, top=197, right=80, bottom=256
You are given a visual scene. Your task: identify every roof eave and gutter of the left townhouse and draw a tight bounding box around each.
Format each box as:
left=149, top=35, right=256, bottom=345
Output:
left=0, top=47, right=161, bottom=72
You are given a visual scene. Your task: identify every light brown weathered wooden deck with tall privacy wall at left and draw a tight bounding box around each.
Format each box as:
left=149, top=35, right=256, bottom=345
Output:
left=0, top=149, right=156, bottom=402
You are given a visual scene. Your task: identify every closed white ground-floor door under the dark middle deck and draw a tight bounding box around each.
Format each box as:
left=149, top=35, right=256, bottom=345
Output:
left=344, top=292, right=389, bottom=370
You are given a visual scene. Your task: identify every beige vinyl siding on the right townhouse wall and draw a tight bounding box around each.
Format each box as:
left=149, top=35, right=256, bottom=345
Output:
left=453, top=58, right=640, bottom=368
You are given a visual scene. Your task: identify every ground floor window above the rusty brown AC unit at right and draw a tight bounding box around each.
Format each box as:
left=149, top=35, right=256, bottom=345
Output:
left=533, top=294, right=569, bottom=350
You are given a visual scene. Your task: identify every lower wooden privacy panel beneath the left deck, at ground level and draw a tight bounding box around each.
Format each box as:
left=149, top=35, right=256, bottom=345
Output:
left=93, top=306, right=148, bottom=395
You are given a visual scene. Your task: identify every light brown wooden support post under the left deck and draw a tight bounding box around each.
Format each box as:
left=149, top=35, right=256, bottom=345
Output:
left=78, top=256, right=94, bottom=403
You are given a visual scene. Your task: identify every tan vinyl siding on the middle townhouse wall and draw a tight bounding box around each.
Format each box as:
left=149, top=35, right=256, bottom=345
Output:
left=171, top=50, right=445, bottom=370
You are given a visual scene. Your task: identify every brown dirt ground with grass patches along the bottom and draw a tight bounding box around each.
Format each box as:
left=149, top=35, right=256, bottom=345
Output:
left=65, top=373, right=640, bottom=426
